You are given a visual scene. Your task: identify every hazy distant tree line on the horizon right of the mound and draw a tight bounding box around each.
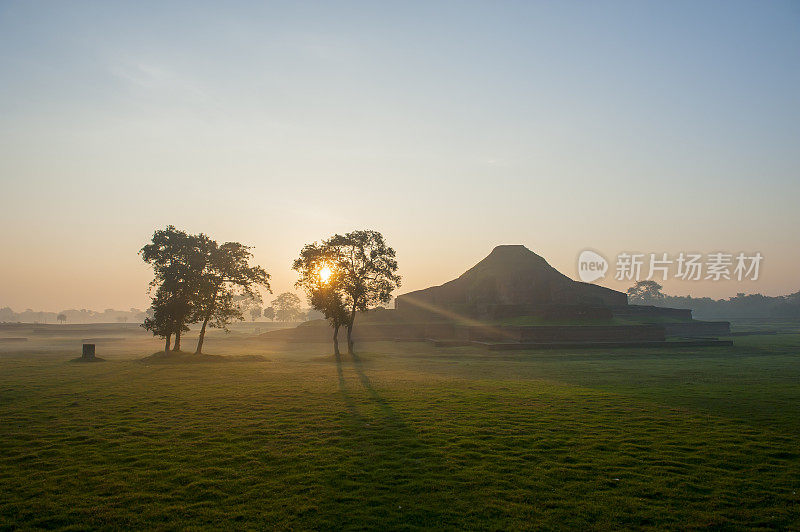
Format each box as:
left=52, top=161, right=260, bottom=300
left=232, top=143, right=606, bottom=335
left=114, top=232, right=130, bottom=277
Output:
left=628, top=280, right=800, bottom=319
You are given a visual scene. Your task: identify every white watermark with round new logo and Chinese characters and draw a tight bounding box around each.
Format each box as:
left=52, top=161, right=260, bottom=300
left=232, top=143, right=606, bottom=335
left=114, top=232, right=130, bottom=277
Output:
left=578, top=249, right=764, bottom=283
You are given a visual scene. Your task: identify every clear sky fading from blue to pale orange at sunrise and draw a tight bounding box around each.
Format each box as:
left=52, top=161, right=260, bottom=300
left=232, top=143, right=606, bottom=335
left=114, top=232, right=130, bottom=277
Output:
left=0, top=0, right=800, bottom=311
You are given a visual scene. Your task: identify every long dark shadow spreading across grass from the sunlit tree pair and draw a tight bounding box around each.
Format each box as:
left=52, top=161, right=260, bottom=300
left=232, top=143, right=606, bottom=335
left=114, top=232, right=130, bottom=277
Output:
left=318, top=355, right=466, bottom=528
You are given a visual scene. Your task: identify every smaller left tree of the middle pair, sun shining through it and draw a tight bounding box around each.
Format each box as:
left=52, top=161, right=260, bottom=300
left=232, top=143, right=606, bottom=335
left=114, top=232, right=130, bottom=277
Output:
left=292, top=242, right=350, bottom=356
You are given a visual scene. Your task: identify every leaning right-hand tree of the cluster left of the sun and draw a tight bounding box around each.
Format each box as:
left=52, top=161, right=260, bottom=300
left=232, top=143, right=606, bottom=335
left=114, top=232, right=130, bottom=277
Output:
left=195, top=238, right=272, bottom=354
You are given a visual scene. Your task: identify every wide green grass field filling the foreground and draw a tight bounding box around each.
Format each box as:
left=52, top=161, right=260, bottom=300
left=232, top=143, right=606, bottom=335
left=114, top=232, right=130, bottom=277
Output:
left=0, top=324, right=800, bottom=529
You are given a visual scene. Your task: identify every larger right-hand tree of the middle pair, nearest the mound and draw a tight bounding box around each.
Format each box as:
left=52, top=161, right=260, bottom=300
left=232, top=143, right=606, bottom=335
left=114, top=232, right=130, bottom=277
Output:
left=293, top=230, right=400, bottom=354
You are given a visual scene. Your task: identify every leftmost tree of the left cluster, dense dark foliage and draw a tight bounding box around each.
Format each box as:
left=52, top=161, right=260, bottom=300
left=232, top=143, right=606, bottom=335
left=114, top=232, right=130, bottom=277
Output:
left=139, top=225, right=202, bottom=351
